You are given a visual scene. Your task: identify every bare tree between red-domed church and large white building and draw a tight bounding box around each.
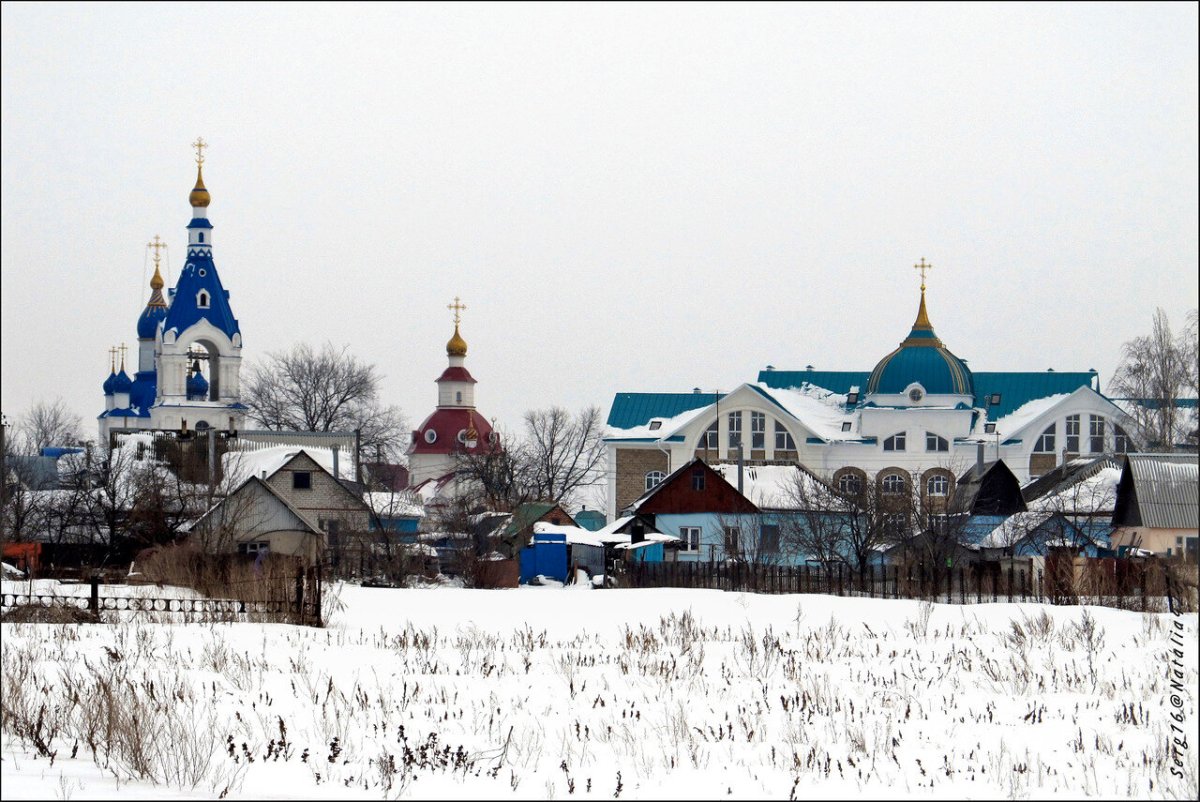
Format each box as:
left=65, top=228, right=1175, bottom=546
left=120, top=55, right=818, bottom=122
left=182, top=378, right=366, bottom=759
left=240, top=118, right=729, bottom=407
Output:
left=520, top=406, right=605, bottom=502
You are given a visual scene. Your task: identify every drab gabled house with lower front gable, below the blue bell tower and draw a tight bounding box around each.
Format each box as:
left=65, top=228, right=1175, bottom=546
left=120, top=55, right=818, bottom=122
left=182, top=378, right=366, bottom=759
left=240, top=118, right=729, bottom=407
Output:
left=191, top=450, right=371, bottom=564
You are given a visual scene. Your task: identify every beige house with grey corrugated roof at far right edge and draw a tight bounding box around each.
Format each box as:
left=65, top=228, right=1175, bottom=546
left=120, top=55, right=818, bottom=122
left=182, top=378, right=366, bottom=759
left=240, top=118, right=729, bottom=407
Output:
left=1112, top=454, right=1200, bottom=562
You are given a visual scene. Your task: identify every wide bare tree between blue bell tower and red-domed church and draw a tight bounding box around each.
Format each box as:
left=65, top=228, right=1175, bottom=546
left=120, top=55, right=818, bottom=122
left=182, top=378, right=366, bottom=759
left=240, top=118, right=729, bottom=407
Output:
left=242, top=342, right=408, bottom=460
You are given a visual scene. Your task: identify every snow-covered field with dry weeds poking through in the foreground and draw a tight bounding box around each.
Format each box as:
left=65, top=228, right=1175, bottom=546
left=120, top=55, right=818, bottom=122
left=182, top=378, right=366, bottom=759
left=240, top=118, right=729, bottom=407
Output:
left=0, top=587, right=1198, bottom=800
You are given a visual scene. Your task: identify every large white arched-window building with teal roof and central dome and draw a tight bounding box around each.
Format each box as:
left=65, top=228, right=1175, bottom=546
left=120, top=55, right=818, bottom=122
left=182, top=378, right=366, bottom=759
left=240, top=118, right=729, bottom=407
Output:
left=606, top=268, right=1134, bottom=520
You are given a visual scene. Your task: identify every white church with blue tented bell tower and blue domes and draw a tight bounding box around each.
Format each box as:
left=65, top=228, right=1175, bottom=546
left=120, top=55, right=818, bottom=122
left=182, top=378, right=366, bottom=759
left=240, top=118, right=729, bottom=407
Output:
left=98, top=139, right=246, bottom=441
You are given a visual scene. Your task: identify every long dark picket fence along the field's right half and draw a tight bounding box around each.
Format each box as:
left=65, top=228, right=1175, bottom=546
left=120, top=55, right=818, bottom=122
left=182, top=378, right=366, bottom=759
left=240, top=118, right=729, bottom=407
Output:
left=619, top=561, right=1171, bottom=611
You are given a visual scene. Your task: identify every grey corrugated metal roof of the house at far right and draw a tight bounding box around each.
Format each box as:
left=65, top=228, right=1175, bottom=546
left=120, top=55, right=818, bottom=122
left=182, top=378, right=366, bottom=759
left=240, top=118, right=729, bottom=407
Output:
left=1121, top=454, right=1200, bottom=529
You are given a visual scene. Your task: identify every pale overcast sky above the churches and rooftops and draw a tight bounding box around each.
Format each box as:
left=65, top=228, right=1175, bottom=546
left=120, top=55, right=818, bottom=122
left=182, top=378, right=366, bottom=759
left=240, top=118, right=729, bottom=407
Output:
left=0, top=2, right=1198, bottom=433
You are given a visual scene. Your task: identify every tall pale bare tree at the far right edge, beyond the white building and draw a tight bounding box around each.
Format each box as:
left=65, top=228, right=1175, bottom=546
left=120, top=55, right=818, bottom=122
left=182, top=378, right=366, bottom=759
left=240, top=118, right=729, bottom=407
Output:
left=1109, top=309, right=1198, bottom=451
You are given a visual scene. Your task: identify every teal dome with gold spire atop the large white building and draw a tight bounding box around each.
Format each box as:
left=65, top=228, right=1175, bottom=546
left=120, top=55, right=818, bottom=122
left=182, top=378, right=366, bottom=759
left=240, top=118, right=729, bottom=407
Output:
left=866, top=287, right=974, bottom=396
